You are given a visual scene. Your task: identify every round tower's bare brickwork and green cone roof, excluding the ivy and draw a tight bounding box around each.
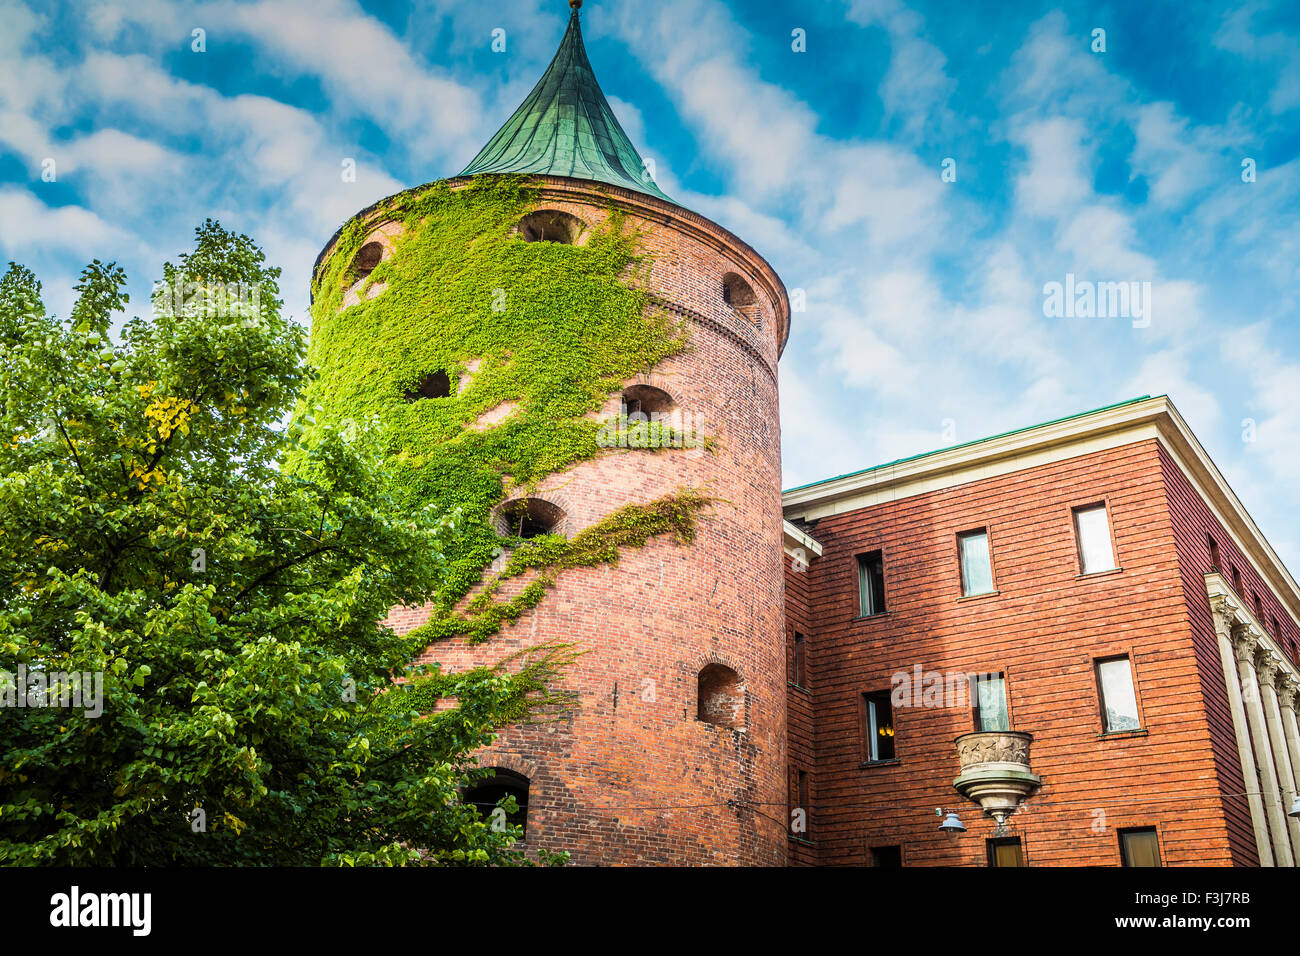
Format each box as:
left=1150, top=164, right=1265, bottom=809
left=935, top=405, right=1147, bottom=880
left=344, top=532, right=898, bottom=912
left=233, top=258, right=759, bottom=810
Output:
left=313, top=3, right=789, bottom=865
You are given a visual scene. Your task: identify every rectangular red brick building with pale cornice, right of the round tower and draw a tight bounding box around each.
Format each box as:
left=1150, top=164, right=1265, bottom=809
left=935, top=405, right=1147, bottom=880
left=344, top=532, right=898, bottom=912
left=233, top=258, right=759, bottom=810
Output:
left=784, top=398, right=1300, bottom=865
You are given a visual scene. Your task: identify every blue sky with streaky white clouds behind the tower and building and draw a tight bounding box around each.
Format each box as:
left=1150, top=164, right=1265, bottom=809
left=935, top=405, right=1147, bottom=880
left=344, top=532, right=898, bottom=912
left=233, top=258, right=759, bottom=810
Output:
left=0, top=0, right=1300, bottom=570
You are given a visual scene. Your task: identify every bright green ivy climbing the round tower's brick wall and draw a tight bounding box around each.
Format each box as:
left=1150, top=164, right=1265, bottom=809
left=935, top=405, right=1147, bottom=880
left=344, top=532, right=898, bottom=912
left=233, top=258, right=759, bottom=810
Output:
left=290, top=176, right=711, bottom=643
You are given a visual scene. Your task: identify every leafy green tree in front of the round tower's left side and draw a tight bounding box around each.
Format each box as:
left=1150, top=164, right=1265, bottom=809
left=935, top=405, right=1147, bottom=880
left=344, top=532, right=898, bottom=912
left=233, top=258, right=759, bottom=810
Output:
left=0, top=221, right=567, bottom=865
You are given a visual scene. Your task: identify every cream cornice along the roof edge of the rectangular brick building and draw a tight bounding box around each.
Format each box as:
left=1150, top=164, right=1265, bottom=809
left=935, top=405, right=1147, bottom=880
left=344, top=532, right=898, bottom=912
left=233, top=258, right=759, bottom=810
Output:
left=783, top=395, right=1300, bottom=627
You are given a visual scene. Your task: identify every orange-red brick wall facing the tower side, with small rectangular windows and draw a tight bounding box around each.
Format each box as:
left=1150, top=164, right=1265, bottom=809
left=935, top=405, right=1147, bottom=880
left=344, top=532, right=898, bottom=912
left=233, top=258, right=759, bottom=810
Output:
left=788, top=441, right=1232, bottom=865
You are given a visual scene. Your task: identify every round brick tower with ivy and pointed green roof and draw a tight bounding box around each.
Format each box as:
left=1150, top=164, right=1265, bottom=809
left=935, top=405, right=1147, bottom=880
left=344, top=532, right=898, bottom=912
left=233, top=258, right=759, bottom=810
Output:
left=312, top=0, right=789, bottom=865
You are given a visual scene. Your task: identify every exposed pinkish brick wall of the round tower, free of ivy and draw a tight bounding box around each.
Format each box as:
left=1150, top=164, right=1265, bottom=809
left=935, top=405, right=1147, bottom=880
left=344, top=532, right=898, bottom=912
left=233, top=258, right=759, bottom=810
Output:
left=340, top=177, right=788, bottom=865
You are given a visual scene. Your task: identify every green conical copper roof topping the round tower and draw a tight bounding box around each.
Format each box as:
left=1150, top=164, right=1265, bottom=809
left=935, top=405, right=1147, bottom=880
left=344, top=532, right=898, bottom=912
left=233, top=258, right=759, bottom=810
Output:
left=460, top=7, right=672, bottom=202
